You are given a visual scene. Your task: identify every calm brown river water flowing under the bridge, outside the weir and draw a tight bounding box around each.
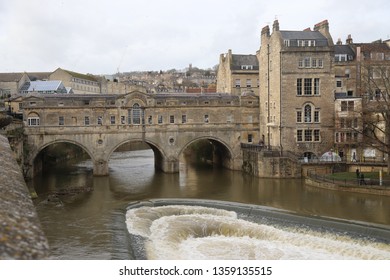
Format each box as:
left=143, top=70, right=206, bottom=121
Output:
left=28, top=150, right=390, bottom=260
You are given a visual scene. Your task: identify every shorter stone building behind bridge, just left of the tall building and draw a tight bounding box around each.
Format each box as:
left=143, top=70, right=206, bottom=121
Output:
left=217, top=50, right=259, bottom=96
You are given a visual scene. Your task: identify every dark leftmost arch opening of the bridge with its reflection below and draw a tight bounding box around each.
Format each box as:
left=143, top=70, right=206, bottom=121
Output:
left=27, top=141, right=93, bottom=200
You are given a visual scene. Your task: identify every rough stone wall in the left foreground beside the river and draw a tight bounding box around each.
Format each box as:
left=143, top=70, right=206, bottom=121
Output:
left=0, top=135, right=49, bottom=260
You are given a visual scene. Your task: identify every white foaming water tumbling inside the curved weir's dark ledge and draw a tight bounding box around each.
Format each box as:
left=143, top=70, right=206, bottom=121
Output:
left=126, top=205, right=390, bottom=260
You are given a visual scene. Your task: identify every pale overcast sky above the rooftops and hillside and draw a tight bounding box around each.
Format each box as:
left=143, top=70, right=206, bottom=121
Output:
left=0, top=0, right=390, bottom=74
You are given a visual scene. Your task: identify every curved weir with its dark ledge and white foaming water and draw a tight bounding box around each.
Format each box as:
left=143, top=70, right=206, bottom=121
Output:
left=126, top=199, right=390, bottom=260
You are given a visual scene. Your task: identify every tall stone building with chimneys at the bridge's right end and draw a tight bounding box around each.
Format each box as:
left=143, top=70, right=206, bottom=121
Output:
left=258, top=20, right=335, bottom=158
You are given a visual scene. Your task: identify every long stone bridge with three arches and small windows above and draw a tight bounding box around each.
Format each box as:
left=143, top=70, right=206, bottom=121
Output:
left=20, top=91, right=260, bottom=177
